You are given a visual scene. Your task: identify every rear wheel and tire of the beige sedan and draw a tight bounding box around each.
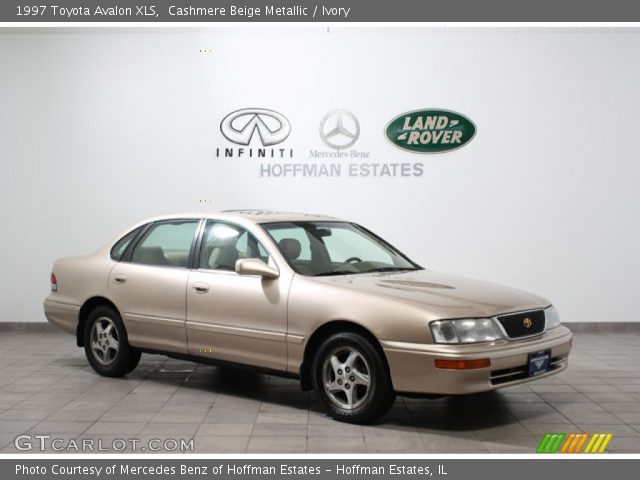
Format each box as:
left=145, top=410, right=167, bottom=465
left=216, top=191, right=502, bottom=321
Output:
left=84, top=306, right=141, bottom=377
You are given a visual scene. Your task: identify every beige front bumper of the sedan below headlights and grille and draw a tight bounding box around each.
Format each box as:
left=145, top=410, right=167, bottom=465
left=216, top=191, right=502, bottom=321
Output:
left=381, top=326, right=573, bottom=395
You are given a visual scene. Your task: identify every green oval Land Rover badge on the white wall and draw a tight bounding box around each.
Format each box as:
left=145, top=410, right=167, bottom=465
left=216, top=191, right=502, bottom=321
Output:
left=385, top=110, right=476, bottom=153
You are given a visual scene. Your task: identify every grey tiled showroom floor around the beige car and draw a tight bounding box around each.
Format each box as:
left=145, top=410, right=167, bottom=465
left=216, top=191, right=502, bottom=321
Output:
left=0, top=331, right=640, bottom=453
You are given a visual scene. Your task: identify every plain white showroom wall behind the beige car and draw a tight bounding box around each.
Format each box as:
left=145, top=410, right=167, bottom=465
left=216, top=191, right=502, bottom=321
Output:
left=0, top=27, right=640, bottom=322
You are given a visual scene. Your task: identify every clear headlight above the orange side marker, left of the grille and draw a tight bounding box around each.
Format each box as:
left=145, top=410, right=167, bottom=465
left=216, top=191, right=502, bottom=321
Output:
left=429, top=318, right=503, bottom=344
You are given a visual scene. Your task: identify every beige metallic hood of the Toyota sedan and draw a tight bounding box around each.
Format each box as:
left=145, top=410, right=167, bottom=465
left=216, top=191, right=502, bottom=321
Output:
left=317, top=270, right=550, bottom=318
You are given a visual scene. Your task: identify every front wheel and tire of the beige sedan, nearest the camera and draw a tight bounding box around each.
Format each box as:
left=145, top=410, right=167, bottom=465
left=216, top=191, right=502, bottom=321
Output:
left=311, top=332, right=396, bottom=423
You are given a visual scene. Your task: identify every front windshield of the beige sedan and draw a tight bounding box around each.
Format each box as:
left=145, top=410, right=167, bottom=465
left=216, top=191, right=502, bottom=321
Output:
left=262, top=222, right=421, bottom=277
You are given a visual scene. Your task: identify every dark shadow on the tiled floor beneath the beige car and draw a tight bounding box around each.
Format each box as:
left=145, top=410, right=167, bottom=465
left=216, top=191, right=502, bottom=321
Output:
left=119, top=360, right=518, bottom=432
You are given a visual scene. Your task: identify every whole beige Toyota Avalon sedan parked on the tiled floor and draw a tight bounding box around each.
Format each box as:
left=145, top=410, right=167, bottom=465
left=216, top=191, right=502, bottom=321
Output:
left=44, top=211, right=572, bottom=422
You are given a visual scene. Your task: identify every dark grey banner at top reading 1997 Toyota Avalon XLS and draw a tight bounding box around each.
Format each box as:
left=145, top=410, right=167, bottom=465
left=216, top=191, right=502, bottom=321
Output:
left=0, top=0, right=640, bottom=23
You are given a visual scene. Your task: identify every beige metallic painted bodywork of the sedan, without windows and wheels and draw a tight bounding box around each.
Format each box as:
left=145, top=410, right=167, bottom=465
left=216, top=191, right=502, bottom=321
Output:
left=45, top=213, right=572, bottom=394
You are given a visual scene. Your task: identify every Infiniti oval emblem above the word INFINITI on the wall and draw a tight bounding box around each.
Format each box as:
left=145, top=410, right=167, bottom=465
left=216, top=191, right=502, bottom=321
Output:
left=220, top=108, right=291, bottom=147
